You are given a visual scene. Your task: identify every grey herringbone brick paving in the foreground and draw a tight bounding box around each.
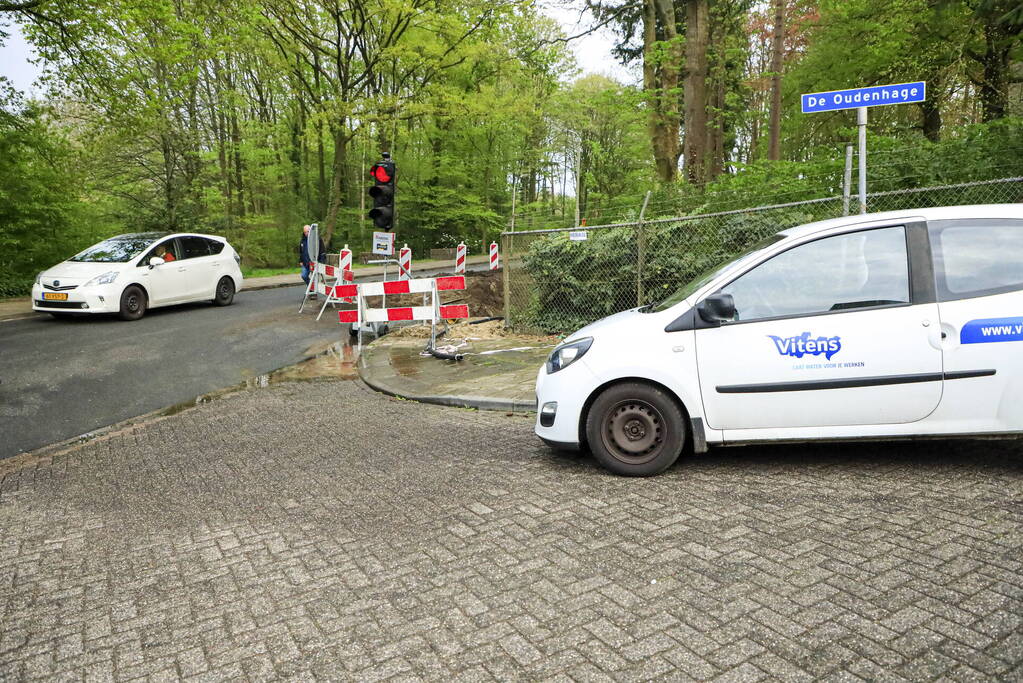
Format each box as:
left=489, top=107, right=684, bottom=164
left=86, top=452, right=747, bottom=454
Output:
left=0, top=382, right=1023, bottom=680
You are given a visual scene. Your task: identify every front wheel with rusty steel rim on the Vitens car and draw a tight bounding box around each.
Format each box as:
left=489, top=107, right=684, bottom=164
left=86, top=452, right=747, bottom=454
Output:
left=586, top=382, right=685, bottom=476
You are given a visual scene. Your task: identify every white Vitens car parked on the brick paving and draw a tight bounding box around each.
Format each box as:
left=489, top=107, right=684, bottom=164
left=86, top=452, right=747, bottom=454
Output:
left=535, top=204, right=1023, bottom=475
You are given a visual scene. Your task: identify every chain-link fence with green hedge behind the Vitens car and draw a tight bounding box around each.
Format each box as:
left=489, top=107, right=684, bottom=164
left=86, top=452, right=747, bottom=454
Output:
left=501, top=178, right=1023, bottom=333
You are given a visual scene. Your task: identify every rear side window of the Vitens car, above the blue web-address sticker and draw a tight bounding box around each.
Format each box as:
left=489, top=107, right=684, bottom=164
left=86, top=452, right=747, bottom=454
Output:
left=929, top=219, right=1023, bottom=302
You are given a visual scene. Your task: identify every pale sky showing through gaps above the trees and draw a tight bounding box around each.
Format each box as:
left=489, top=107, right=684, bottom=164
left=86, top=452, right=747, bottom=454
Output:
left=0, top=0, right=638, bottom=94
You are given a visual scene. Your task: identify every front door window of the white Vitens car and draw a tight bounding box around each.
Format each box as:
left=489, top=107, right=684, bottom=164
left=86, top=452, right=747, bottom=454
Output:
left=721, top=226, right=909, bottom=321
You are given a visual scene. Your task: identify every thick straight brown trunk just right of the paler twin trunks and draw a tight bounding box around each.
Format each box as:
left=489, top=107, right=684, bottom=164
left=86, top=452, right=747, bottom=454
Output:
left=683, top=0, right=709, bottom=186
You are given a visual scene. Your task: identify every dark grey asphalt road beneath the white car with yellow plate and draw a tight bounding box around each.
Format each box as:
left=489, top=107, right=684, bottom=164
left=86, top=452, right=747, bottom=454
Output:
left=0, top=287, right=348, bottom=458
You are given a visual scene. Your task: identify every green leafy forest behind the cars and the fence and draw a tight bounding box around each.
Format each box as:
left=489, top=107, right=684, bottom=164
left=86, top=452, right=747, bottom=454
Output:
left=0, top=0, right=1023, bottom=295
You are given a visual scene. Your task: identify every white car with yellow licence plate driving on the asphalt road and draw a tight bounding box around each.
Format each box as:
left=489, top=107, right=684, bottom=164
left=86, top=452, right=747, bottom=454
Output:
left=32, top=232, right=242, bottom=320
